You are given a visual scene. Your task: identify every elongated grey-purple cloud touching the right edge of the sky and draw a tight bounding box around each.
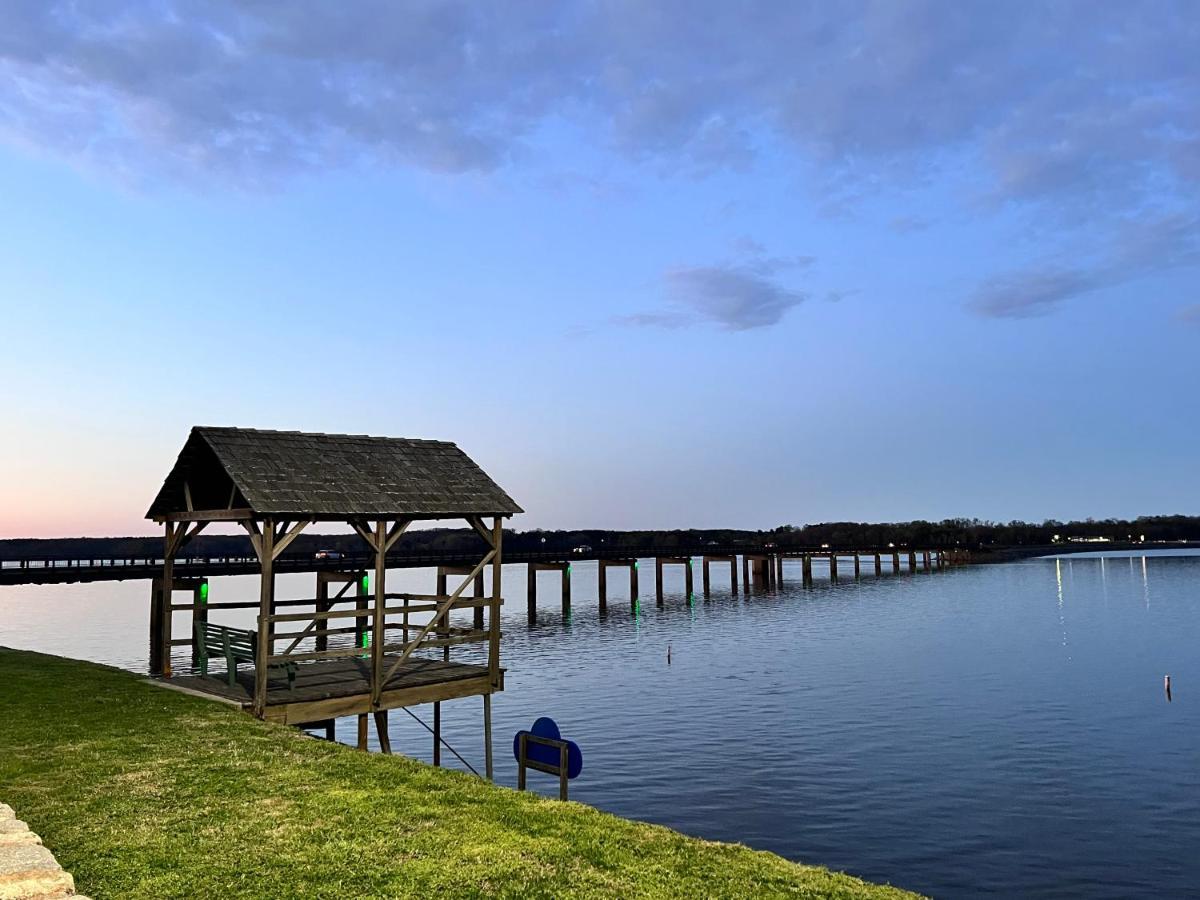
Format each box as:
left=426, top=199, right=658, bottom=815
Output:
left=968, top=214, right=1200, bottom=319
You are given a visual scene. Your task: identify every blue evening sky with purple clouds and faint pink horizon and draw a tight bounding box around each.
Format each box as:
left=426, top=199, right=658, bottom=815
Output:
left=0, top=0, right=1200, bottom=536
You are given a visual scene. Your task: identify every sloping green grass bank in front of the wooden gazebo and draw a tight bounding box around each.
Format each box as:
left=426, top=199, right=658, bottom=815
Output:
left=0, top=649, right=911, bottom=900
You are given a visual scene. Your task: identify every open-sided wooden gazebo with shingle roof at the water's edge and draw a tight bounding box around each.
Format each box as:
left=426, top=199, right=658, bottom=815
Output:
left=146, top=427, right=522, bottom=775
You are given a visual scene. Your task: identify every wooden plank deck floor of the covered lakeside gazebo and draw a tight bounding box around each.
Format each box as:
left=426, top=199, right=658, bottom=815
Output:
left=162, top=656, right=504, bottom=725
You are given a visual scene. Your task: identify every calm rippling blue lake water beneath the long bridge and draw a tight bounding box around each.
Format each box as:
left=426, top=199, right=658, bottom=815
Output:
left=0, top=556, right=1200, bottom=898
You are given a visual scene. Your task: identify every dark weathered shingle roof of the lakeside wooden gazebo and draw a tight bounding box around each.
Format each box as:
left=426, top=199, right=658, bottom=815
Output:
left=146, top=426, right=522, bottom=518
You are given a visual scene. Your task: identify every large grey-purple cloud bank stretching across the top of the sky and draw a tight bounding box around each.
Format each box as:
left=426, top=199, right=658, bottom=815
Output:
left=0, top=0, right=1200, bottom=211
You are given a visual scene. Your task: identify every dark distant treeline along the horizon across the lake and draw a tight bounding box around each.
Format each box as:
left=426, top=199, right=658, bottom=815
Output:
left=0, top=516, right=1200, bottom=559
